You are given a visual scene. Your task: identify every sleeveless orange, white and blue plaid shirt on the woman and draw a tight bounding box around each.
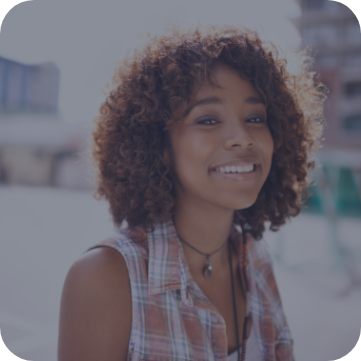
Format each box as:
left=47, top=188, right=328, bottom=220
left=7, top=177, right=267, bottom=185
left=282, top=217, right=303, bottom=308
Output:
left=91, top=221, right=294, bottom=361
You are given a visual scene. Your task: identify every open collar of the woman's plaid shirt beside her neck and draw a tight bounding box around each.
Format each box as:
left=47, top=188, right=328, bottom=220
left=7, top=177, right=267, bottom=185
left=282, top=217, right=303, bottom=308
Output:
left=147, top=220, right=242, bottom=306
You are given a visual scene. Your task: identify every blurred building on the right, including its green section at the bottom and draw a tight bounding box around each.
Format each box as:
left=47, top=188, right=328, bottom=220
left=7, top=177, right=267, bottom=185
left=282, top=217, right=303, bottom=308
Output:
left=291, top=0, right=361, bottom=214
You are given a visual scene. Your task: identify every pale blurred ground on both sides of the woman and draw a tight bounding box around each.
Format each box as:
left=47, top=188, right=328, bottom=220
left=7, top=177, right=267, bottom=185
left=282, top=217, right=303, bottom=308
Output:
left=0, top=186, right=361, bottom=361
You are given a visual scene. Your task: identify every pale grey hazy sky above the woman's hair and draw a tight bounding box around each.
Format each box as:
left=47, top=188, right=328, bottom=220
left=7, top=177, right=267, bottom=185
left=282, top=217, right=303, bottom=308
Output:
left=0, top=0, right=301, bottom=122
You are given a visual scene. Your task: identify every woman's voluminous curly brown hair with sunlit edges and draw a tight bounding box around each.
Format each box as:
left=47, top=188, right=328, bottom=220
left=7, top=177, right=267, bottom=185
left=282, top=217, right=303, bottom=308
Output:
left=92, top=26, right=327, bottom=239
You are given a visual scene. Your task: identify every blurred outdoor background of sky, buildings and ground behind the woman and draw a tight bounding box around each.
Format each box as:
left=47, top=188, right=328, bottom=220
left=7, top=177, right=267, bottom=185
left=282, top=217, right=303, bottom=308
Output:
left=0, top=0, right=361, bottom=361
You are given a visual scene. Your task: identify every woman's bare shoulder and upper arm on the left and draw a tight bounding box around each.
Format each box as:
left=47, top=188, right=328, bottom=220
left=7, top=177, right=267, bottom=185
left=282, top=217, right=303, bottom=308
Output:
left=58, top=247, right=132, bottom=361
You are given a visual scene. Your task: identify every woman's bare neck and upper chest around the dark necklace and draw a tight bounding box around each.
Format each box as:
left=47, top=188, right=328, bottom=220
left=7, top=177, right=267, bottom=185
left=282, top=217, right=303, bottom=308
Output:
left=173, top=201, right=234, bottom=279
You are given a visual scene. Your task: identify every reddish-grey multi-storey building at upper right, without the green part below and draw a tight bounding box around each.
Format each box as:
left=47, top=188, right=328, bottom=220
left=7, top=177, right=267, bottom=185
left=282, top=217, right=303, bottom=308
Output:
left=292, top=0, right=361, bottom=151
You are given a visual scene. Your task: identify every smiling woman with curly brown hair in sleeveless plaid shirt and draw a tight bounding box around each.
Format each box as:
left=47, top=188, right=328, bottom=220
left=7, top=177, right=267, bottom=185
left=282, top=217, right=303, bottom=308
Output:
left=59, top=23, right=324, bottom=361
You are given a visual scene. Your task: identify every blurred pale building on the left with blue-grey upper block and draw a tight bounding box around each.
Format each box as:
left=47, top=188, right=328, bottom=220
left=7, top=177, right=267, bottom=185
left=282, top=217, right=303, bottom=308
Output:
left=0, top=57, right=92, bottom=189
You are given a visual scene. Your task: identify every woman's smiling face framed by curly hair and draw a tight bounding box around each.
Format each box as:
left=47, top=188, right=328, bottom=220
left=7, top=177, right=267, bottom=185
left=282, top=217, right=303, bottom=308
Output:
left=165, top=65, right=273, bottom=210
